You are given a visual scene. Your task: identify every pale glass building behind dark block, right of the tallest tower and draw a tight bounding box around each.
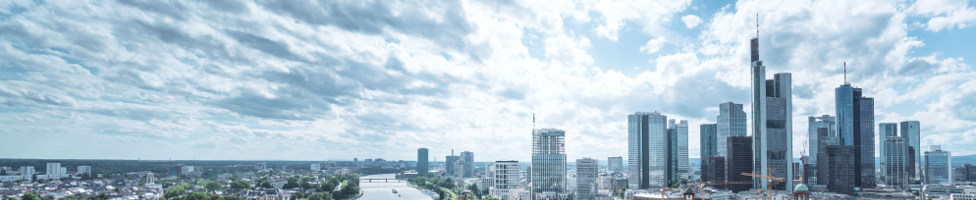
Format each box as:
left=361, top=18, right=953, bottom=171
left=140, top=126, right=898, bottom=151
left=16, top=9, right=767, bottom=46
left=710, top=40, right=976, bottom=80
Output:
left=804, top=115, right=837, bottom=185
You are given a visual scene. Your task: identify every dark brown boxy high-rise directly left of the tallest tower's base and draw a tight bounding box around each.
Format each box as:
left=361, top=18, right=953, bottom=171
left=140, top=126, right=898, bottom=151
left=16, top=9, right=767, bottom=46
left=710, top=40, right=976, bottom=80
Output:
left=726, top=136, right=753, bottom=192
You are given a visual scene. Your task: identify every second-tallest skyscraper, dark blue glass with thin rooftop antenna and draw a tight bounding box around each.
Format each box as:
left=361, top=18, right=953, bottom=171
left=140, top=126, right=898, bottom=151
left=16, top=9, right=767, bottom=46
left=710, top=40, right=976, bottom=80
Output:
left=834, top=83, right=875, bottom=188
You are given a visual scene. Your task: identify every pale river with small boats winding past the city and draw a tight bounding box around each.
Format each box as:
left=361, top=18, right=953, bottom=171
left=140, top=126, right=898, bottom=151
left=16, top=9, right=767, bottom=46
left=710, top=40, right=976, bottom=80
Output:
left=359, top=174, right=433, bottom=200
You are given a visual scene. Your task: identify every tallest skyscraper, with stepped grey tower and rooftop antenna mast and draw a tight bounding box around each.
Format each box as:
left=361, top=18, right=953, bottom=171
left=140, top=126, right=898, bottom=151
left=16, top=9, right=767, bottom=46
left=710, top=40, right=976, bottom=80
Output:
left=751, top=35, right=793, bottom=191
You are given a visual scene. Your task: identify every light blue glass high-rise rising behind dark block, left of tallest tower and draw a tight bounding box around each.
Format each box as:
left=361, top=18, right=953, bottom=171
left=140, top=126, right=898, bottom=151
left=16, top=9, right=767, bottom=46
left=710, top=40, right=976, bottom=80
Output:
left=716, top=102, right=748, bottom=158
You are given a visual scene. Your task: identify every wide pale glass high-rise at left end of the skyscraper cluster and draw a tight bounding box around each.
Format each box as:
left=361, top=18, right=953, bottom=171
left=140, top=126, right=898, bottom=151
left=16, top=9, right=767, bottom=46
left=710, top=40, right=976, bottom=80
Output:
left=627, top=112, right=671, bottom=189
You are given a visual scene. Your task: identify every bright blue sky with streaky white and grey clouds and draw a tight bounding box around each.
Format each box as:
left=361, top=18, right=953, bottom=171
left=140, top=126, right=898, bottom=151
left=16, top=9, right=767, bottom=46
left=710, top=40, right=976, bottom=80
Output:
left=0, top=0, right=976, bottom=161
